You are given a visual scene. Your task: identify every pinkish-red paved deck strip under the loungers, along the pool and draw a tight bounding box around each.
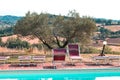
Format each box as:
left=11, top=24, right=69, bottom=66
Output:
left=0, top=61, right=120, bottom=70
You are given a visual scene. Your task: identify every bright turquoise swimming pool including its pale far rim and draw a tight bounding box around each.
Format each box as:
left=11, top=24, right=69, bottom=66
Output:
left=0, top=68, right=120, bottom=80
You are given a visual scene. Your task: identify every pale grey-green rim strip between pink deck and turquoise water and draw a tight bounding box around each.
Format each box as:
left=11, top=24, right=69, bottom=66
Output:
left=0, top=68, right=120, bottom=74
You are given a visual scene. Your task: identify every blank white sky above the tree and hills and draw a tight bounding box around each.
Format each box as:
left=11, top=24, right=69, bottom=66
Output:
left=0, top=0, right=120, bottom=19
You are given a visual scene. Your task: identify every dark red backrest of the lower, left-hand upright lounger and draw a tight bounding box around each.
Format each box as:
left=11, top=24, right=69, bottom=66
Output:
left=53, top=49, right=66, bottom=61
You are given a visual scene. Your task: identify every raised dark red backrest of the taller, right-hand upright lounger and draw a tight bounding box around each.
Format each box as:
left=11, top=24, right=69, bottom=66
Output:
left=68, top=44, right=80, bottom=56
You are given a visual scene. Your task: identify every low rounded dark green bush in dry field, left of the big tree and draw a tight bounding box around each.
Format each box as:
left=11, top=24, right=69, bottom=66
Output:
left=6, top=38, right=30, bottom=49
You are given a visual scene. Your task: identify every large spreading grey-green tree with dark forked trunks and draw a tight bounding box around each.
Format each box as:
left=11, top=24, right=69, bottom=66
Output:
left=14, top=11, right=97, bottom=49
